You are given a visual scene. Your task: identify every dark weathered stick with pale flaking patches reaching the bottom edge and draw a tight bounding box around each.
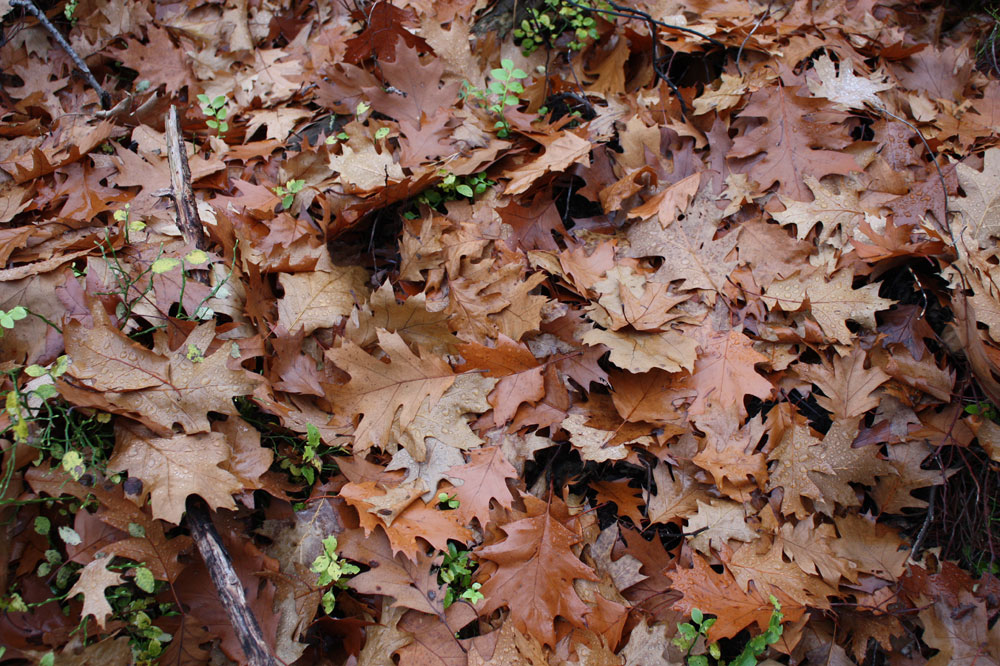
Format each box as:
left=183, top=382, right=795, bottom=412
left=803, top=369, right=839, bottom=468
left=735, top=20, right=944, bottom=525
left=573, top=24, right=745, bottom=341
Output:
left=187, top=495, right=278, bottom=666
